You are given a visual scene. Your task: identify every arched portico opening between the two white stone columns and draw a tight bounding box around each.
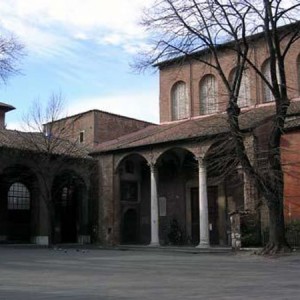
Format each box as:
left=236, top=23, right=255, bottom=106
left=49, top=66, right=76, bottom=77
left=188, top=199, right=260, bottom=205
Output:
left=157, top=148, right=199, bottom=245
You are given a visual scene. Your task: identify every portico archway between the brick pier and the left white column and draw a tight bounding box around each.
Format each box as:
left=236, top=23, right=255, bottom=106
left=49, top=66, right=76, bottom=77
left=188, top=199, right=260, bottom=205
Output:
left=117, top=154, right=151, bottom=244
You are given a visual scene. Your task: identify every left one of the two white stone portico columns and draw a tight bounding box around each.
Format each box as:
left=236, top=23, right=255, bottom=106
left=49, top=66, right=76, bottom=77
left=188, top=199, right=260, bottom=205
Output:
left=149, top=164, right=159, bottom=246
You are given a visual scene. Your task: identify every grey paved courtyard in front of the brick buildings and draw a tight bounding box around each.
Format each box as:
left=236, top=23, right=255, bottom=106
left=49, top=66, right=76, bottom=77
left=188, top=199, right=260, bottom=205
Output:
left=0, top=247, right=300, bottom=300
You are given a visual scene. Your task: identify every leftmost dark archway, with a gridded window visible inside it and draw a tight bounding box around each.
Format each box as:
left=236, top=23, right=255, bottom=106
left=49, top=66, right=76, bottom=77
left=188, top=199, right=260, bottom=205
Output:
left=0, top=165, right=38, bottom=243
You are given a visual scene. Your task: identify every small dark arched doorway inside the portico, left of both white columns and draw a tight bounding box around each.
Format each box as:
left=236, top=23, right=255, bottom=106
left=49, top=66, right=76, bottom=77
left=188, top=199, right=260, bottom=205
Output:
left=122, top=208, right=138, bottom=244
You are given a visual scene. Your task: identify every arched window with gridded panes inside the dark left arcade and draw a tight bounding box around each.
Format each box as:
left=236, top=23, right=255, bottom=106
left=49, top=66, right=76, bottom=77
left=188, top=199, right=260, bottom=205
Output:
left=7, top=182, right=30, bottom=210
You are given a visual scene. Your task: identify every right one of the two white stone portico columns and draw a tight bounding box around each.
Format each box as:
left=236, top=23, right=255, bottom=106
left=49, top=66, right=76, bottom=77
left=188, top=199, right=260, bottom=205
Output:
left=197, top=157, right=209, bottom=248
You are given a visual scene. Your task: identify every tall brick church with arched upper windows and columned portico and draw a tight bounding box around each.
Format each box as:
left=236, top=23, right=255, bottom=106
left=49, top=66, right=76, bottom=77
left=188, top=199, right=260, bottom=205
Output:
left=91, top=27, right=300, bottom=247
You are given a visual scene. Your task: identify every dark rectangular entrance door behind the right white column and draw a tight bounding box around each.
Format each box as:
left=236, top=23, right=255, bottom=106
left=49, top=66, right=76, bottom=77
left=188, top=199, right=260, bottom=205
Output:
left=191, top=186, right=219, bottom=245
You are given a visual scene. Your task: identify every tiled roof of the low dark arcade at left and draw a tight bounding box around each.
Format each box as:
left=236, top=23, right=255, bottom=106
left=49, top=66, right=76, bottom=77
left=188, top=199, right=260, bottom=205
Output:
left=0, top=129, right=89, bottom=158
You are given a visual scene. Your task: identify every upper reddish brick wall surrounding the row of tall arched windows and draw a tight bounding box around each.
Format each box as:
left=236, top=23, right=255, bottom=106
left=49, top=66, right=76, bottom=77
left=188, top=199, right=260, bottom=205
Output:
left=159, top=39, right=300, bottom=123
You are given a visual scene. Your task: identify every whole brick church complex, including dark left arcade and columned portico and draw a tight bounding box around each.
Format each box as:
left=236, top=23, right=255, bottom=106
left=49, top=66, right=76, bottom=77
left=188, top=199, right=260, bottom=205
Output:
left=0, top=25, right=300, bottom=247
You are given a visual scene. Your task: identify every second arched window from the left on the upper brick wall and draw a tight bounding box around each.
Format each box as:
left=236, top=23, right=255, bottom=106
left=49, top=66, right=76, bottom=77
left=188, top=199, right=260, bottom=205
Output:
left=199, top=75, right=218, bottom=115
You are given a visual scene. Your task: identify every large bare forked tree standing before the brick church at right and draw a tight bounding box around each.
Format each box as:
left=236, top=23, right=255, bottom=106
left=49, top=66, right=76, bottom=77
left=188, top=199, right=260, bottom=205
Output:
left=136, top=0, right=300, bottom=253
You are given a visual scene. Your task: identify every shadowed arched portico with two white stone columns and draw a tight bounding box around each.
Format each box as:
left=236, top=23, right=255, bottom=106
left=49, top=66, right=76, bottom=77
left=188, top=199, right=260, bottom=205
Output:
left=112, top=139, right=242, bottom=247
